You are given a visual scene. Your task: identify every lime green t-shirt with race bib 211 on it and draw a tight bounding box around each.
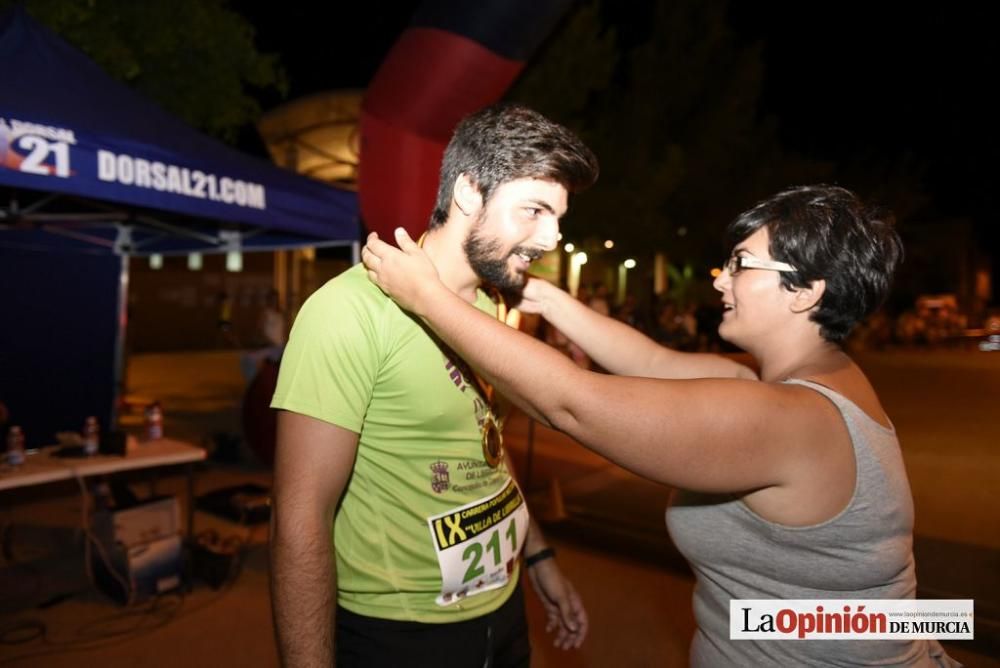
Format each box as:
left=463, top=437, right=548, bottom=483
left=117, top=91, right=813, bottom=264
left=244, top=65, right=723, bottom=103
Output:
left=271, top=265, right=528, bottom=623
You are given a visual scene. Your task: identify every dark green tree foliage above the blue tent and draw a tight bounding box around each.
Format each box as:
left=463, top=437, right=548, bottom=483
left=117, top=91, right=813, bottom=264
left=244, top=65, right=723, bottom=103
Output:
left=6, top=0, right=286, bottom=141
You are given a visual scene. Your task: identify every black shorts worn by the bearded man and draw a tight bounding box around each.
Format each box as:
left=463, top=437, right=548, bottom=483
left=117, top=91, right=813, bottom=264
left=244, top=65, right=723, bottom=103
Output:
left=334, top=583, right=531, bottom=668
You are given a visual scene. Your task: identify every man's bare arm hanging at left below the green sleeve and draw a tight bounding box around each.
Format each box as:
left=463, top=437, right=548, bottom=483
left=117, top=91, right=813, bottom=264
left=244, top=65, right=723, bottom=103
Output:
left=271, top=411, right=358, bottom=668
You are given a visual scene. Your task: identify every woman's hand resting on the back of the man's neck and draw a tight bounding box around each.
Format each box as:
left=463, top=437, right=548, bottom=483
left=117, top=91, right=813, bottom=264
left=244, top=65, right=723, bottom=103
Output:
left=361, top=227, right=438, bottom=315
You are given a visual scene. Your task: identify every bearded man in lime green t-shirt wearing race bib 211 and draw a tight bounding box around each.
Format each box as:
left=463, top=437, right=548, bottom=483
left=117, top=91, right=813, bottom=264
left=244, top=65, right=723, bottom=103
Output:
left=271, top=106, right=597, bottom=668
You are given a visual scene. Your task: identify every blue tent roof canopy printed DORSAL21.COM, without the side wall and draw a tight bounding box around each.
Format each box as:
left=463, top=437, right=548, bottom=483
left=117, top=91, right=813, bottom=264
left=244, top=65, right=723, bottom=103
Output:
left=0, top=6, right=359, bottom=253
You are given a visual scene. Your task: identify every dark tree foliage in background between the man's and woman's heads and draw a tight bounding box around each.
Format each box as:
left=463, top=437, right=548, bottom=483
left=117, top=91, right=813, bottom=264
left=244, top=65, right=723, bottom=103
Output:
left=510, top=0, right=832, bottom=268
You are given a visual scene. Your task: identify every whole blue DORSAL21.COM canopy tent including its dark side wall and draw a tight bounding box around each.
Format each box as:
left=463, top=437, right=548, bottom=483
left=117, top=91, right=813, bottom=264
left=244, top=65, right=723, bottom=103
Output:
left=0, top=7, right=360, bottom=444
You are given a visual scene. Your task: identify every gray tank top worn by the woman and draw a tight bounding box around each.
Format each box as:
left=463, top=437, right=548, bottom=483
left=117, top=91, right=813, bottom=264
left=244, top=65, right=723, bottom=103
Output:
left=667, top=380, right=958, bottom=668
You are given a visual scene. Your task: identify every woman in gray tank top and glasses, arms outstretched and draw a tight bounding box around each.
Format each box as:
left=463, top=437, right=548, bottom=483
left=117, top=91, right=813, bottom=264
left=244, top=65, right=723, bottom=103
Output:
left=363, top=186, right=956, bottom=667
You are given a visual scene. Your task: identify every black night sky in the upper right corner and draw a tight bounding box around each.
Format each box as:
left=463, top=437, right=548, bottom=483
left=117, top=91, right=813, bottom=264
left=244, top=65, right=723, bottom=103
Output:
left=730, top=2, right=998, bottom=224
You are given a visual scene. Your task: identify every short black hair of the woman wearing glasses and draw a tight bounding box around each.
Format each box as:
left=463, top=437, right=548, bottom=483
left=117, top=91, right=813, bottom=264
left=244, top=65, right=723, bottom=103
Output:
left=726, top=185, right=903, bottom=342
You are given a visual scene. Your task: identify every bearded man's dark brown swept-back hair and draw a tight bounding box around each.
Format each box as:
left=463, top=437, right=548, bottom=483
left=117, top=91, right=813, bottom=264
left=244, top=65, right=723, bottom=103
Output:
left=430, top=105, right=598, bottom=228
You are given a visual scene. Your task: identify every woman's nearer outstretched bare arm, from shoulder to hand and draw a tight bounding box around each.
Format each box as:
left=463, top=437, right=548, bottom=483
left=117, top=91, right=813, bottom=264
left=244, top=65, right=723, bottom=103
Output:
left=362, top=229, right=839, bottom=492
